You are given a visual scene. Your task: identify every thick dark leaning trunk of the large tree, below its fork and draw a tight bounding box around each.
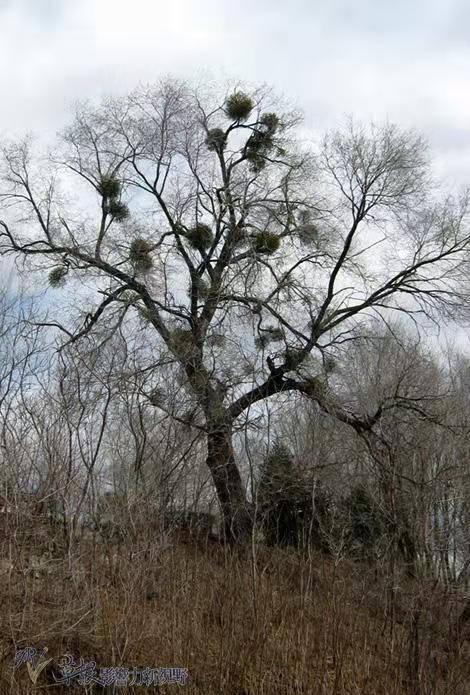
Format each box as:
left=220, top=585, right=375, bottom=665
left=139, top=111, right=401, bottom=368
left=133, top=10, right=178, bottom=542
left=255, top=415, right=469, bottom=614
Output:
left=207, top=427, right=253, bottom=545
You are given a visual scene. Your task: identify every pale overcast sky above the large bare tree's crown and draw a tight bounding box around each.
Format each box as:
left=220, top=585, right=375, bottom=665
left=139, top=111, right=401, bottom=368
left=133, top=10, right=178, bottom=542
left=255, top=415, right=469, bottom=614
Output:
left=0, top=0, right=470, bottom=184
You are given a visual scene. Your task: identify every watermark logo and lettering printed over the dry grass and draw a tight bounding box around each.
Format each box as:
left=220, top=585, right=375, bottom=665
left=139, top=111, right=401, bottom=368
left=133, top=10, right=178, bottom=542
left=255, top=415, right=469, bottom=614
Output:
left=14, top=647, right=188, bottom=687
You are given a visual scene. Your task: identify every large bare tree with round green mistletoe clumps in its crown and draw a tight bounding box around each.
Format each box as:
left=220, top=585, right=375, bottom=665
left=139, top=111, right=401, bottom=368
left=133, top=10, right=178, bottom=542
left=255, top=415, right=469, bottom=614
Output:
left=0, top=80, right=470, bottom=541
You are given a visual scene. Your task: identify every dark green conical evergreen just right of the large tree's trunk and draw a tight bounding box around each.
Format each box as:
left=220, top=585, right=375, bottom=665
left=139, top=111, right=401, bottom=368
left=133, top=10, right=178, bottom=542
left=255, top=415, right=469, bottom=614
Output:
left=257, top=442, right=330, bottom=550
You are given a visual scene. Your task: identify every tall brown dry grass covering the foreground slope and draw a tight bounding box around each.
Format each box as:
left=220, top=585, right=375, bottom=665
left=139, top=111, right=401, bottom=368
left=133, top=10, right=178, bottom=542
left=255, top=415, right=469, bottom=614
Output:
left=0, top=529, right=470, bottom=695
